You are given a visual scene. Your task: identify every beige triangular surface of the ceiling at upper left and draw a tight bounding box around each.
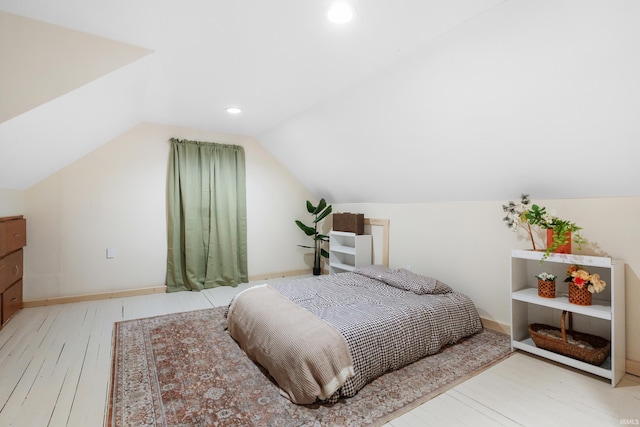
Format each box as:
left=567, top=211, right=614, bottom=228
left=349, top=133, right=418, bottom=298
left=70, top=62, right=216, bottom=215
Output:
left=0, top=12, right=151, bottom=123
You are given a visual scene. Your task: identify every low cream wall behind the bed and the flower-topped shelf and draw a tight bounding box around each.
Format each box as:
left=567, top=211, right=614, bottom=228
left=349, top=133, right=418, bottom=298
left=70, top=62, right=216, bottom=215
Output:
left=334, top=194, right=640, bottom=361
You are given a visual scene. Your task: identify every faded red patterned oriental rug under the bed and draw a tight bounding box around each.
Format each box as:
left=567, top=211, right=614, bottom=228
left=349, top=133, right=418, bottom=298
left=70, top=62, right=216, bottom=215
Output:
left=107, top=307, right=511, bottom=427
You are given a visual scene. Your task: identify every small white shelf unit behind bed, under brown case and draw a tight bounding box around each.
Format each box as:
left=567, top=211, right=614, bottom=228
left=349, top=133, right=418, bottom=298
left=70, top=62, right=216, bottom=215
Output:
left=329, top=230, right=372, bottom=274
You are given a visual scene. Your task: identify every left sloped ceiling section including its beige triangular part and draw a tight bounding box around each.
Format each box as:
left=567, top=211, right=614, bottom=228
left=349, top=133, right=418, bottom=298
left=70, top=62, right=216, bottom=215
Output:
left=0, top=12, right=151, bottom=189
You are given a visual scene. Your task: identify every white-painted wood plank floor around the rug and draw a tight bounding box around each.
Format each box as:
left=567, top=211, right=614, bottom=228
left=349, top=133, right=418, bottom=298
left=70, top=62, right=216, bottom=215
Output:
left=0, top=279, right=640, bottom=427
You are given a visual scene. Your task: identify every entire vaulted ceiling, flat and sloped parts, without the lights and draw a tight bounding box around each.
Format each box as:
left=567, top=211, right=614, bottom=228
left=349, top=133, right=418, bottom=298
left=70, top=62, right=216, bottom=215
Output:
left=0, top=0, right=640, bottom=202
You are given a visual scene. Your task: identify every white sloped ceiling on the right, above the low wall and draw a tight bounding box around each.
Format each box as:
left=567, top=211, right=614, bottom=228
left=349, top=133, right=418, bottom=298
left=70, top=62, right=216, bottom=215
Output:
left=261, top=0, right=640, bottom=203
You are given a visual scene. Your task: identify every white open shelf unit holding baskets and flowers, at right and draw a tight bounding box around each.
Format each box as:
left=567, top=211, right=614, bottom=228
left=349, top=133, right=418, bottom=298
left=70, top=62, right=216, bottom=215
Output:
left=511, top=250, right=626, bottom=387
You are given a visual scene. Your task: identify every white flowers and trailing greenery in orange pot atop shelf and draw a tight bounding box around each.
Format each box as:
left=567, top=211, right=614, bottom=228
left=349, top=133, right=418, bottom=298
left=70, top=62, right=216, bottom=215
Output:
left=502, top=194, right=584, bottom=260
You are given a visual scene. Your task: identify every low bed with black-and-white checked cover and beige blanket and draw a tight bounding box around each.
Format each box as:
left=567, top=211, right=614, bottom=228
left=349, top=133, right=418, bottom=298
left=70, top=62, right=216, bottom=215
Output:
left=227, top=266, right=482, bottom=404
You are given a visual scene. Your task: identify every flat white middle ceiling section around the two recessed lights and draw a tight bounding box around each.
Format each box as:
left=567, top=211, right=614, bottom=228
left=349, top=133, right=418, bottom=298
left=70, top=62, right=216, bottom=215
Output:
left=0, top=0, right=500, bottom=135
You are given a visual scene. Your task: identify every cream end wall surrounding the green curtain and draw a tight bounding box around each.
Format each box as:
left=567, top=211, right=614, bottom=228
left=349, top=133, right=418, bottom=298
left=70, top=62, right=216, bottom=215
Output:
left=24, top=124, right=312, bottom=301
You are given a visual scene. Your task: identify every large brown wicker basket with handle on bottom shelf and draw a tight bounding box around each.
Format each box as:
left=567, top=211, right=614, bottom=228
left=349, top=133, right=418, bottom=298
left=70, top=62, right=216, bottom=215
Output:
left=529, top=310, right=611, bottom=366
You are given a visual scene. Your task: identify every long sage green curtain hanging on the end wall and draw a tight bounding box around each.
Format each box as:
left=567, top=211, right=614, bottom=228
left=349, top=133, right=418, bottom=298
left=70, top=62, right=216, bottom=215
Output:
left=167, top=138, right=249, bottom=292
